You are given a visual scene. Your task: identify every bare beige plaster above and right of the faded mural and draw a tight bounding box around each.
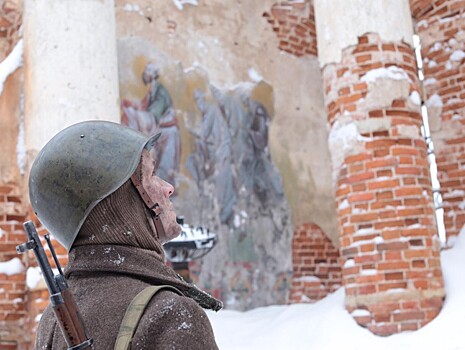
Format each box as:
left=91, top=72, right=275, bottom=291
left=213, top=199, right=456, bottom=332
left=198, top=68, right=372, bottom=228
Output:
left=116, top=0, right=337, bottom=242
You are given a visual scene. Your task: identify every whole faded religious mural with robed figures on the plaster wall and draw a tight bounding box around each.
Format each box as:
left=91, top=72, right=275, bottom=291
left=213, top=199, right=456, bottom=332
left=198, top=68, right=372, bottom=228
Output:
left=119, top=39, right=292, bottom=309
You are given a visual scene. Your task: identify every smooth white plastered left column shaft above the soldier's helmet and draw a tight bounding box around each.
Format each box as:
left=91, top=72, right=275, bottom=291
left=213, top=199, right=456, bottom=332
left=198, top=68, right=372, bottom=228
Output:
left=24, top=0, right=120, bottom=159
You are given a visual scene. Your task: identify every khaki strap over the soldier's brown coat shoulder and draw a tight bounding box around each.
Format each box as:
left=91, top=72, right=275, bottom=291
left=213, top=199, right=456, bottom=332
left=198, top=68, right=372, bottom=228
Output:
left=114, top=285, right=182, bottom=350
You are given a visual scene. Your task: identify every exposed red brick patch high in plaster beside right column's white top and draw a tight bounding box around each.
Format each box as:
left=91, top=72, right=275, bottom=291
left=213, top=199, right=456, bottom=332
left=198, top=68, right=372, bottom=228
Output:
left=263, top=0, right=317, bottom=57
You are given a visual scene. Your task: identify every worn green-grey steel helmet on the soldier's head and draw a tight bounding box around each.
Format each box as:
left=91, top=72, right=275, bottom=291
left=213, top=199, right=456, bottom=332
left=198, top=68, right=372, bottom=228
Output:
left=29, top=120, right=160, bottom=250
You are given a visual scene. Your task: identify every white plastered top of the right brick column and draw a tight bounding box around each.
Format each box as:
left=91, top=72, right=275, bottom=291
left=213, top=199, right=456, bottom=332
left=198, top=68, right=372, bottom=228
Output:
left=315, top=0, right=413, bottom=67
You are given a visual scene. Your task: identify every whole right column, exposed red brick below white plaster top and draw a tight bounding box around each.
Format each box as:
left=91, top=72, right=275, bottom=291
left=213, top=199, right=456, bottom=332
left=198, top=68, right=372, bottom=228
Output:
left=315, top=0, right=444, bottom=335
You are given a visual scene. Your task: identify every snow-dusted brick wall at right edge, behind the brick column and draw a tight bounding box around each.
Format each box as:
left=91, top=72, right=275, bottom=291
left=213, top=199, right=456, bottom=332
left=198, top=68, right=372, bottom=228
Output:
left=410, top=0, right=465, bottom=242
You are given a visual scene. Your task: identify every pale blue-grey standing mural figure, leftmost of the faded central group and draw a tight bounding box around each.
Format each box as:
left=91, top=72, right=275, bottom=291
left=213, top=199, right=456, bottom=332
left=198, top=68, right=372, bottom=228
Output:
left=187, top=89, right=236, bottom=223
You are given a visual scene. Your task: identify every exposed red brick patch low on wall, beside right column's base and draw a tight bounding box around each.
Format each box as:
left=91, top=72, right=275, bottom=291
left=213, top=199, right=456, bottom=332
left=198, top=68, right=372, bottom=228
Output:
left=289, top=223, right=342, bottom=303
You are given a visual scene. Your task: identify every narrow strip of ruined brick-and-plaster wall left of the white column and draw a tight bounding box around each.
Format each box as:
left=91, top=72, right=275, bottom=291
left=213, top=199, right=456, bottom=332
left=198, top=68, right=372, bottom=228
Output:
left=0, top=1, right=30, bottom=349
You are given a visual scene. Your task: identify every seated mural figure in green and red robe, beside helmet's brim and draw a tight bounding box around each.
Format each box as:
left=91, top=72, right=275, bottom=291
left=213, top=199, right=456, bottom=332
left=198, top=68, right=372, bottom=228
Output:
left=122, top=63, right=181, bottom=185
